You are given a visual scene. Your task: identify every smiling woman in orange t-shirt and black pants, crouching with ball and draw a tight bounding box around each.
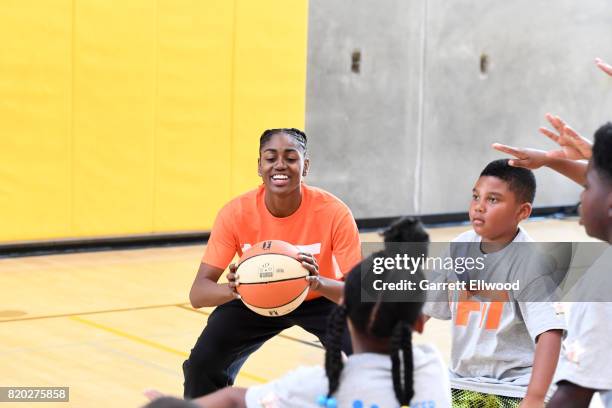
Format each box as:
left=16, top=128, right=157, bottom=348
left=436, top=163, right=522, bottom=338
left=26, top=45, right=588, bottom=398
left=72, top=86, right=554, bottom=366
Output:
left=183, top=129, right=361, bottom=398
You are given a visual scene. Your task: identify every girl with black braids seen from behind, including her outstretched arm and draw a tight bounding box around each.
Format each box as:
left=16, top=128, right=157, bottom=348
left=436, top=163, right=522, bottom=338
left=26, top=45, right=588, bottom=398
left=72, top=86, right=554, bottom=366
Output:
left=149, top=218, right=450, bottom=408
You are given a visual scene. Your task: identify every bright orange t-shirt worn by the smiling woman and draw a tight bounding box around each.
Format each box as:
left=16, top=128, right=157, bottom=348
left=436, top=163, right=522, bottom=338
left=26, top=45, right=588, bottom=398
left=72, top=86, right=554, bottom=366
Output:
left=202, top=183, right=361, bottom=299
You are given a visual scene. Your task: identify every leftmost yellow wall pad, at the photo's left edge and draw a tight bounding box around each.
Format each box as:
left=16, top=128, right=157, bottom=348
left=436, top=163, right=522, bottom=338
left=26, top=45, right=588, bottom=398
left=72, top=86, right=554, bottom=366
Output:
left=0, top=0, right=72, bottom=241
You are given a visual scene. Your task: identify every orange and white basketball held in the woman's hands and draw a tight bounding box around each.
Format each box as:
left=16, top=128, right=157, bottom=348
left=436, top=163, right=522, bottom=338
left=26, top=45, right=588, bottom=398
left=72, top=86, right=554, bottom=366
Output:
left=237, top=240, right=308, bottom=317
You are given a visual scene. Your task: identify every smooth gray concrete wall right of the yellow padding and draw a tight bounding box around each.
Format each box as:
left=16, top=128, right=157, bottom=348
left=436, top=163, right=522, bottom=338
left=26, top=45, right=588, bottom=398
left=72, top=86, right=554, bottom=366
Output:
left=306, top=0, right=612, bottom=218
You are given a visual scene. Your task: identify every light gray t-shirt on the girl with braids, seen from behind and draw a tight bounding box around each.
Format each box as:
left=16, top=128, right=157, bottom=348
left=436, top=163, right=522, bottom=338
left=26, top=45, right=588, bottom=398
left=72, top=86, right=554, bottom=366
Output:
left=245, top=345, right=451, bottom=408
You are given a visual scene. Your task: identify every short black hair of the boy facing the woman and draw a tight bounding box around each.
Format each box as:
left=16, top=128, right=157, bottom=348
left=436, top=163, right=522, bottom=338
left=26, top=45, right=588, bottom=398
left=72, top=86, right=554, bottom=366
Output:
left=480, top=159, right=536, bottom=203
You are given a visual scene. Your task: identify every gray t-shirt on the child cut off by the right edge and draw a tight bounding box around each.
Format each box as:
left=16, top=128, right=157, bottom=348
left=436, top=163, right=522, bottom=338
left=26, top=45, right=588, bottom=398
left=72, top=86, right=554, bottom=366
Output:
left=555, top=247, right=612, bottom=408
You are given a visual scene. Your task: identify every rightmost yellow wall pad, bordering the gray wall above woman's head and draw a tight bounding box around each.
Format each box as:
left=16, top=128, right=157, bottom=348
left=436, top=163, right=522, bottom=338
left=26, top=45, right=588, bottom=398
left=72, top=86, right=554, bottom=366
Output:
left=232, top=0, right=308, bottom=194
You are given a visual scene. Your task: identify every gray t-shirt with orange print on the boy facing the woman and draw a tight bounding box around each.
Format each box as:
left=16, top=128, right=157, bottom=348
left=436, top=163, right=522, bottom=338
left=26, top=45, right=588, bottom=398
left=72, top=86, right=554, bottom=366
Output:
left=424, top=229, right=565, bottom=398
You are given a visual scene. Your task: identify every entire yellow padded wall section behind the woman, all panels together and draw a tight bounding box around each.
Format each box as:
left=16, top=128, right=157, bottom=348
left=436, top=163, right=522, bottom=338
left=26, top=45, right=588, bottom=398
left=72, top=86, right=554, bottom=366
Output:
left=0, top=0, right=307, bottom=242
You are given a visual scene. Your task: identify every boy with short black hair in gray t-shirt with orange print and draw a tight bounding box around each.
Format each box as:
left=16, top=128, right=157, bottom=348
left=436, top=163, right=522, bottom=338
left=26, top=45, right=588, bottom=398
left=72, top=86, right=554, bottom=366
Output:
left=424, top=160, right=565, bottom=407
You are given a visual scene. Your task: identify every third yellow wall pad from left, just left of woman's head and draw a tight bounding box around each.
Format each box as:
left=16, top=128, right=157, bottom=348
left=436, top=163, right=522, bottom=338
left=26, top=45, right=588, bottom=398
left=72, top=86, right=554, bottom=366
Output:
left=154, top=0, right=234, bottom=231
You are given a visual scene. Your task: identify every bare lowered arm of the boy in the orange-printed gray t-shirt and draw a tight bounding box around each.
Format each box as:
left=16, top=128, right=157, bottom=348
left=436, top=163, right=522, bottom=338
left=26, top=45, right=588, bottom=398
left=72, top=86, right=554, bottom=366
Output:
left=520, top=330, right=563, bottom=408
